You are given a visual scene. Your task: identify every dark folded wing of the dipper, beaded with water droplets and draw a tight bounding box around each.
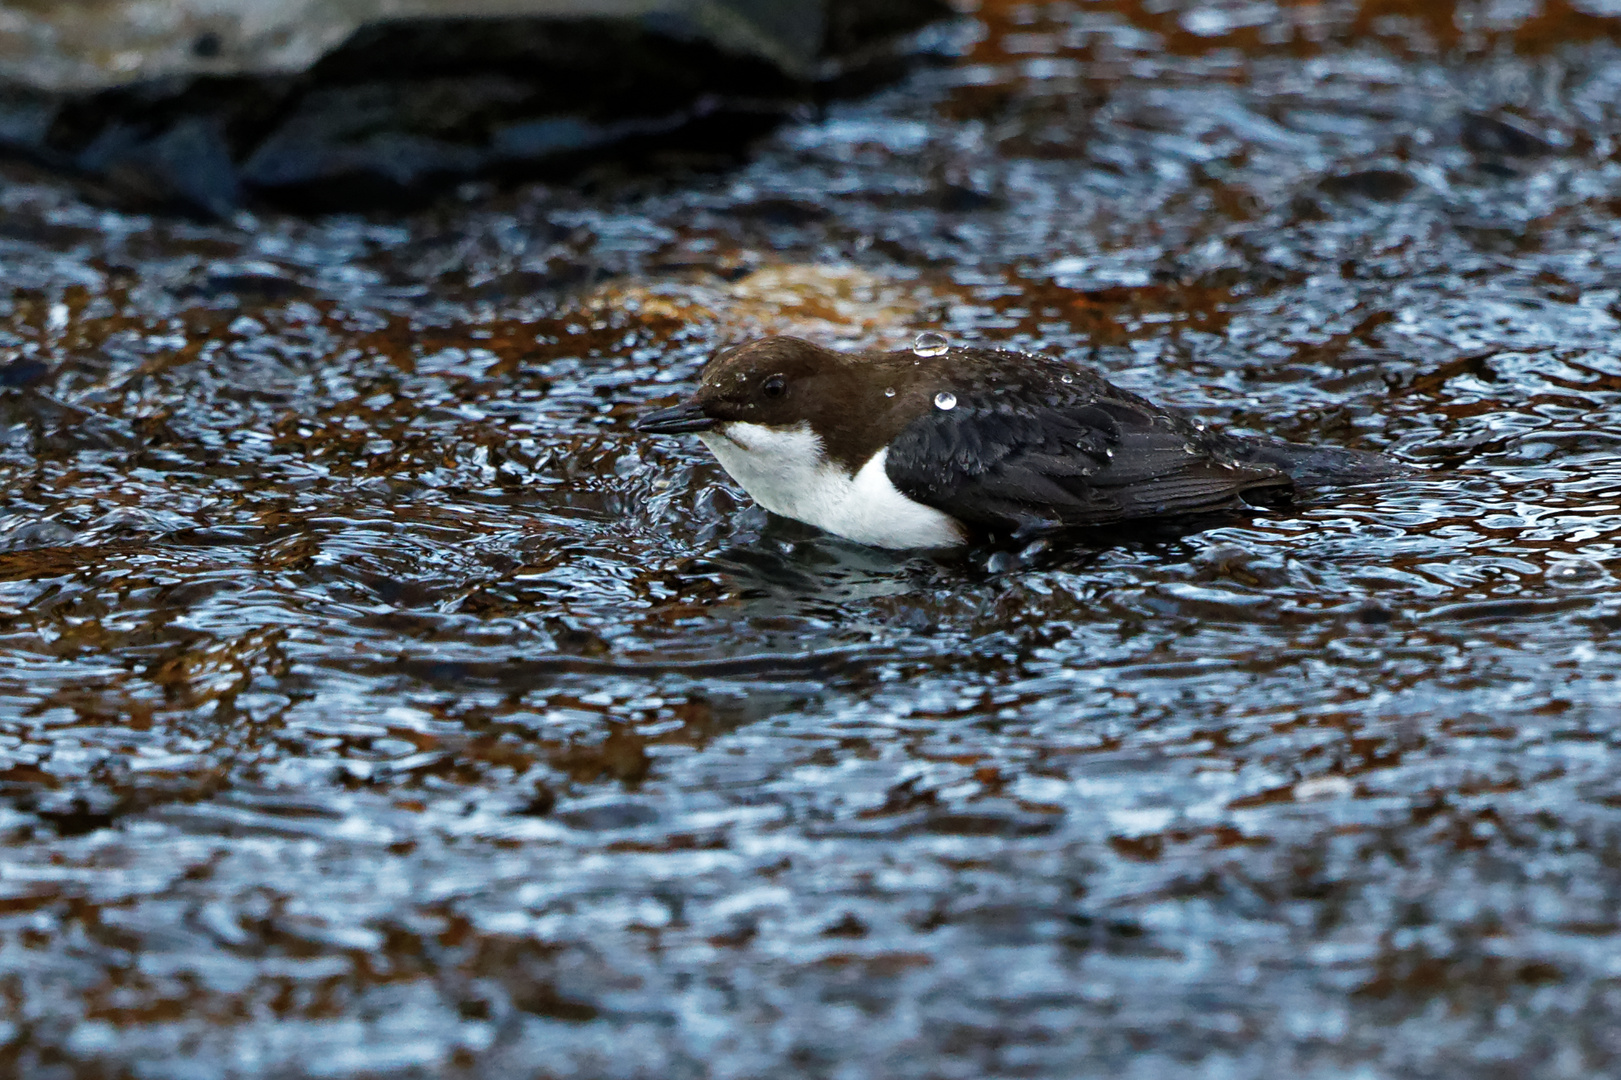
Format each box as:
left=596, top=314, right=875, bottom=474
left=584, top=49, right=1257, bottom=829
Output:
left=885, top=366, right=1290, bottom=530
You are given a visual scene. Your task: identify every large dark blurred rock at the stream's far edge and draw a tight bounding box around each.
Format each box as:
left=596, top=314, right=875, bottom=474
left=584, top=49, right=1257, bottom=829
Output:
left=0, top=0, right=950, bottom=216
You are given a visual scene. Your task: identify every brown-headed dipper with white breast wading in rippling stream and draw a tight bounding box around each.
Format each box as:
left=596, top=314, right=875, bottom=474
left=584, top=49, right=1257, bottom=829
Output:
left=637, top=336, right=1404, bottom=548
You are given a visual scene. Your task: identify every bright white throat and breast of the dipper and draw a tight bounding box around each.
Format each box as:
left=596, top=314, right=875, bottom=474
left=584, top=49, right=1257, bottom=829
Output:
left=699, top=423, right=963, bottom=548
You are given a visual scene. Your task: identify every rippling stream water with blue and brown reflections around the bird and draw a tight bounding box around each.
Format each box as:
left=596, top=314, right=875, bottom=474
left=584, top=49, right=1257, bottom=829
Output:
left=0, top=0, right=1621, bottom=1078
